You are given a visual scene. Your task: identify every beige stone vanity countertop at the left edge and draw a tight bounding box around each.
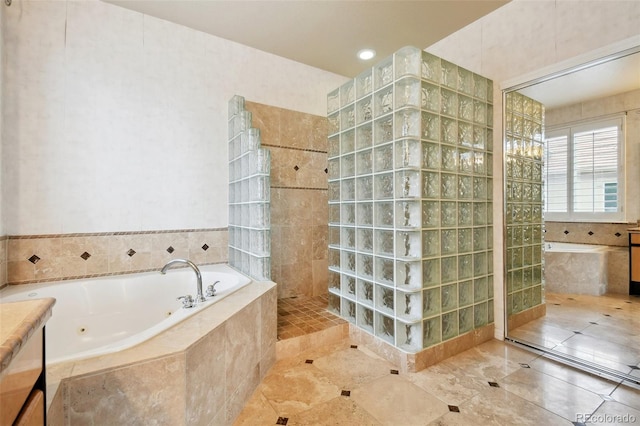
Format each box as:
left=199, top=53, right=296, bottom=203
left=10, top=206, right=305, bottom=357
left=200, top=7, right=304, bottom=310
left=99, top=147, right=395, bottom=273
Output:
left=0, top=297, right=56, bottom=373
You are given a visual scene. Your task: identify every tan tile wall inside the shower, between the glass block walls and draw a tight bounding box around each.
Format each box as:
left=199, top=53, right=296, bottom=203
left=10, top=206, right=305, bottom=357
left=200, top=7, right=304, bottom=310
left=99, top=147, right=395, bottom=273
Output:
left=245, top=102, right=328, bottom=298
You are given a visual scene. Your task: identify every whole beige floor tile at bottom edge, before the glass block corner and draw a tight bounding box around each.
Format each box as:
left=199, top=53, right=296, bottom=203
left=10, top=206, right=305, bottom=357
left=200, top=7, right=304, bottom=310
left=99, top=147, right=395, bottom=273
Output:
left=351, top=375, right=449, bottom=426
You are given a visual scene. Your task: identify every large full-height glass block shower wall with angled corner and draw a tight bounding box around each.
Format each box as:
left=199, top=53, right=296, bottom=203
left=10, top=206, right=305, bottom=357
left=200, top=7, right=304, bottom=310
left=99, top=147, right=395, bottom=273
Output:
left=327, top=47, right=493, bottom=353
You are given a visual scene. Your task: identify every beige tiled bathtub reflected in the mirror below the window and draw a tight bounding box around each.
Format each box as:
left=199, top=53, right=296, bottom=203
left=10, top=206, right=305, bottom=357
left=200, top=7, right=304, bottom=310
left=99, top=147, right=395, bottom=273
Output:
left=544, top=242, right=614, bottom=296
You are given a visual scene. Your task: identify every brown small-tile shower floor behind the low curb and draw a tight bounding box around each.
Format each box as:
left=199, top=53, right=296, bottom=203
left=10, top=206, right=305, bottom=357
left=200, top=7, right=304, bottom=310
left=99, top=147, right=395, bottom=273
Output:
left=278, top=295, right=346, bottom=340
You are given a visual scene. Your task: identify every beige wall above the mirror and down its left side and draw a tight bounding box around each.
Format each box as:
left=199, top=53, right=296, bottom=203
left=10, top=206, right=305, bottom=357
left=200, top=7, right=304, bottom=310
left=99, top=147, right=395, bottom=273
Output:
left=426, top=0, right=640, bottom=339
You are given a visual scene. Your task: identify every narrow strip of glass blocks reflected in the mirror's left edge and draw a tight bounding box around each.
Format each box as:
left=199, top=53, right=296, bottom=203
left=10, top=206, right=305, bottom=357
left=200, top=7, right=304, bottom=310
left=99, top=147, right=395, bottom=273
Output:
left=505, top=92, right=544, bottom=315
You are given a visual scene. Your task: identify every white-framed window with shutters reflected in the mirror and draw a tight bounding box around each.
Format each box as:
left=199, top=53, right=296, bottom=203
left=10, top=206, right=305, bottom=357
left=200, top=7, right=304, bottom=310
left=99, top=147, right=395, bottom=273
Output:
left=545, top=118, right=624, bottom=221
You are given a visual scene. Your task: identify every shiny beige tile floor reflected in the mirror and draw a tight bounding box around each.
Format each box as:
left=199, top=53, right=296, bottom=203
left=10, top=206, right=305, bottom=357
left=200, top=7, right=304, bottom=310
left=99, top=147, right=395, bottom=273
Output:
left=509, top=293, right=640, bottom=378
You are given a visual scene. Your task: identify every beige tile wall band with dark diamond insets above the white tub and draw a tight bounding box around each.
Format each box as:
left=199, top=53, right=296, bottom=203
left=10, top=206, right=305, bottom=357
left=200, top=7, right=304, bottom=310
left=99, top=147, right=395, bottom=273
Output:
left=5, top=228, right=228, bottom=284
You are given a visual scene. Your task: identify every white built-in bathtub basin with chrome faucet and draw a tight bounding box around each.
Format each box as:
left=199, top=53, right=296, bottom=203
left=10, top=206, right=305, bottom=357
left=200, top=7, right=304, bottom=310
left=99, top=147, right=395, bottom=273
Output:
left=0, top=265, right=251, bottom=364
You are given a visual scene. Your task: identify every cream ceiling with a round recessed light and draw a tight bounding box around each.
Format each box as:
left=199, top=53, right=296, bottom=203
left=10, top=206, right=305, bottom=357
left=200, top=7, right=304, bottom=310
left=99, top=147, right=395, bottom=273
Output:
left=103, top=0, right=508, bottom=77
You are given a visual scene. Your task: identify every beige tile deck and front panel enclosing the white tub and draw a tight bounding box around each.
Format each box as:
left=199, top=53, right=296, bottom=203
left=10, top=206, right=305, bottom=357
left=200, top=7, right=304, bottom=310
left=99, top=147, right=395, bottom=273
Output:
left=47, top=281, right=277, bottom=425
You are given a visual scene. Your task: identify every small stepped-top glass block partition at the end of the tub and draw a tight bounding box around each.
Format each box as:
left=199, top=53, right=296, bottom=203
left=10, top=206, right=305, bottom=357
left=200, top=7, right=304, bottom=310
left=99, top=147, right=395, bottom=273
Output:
left=229, top=96, right=271, bottom=281
